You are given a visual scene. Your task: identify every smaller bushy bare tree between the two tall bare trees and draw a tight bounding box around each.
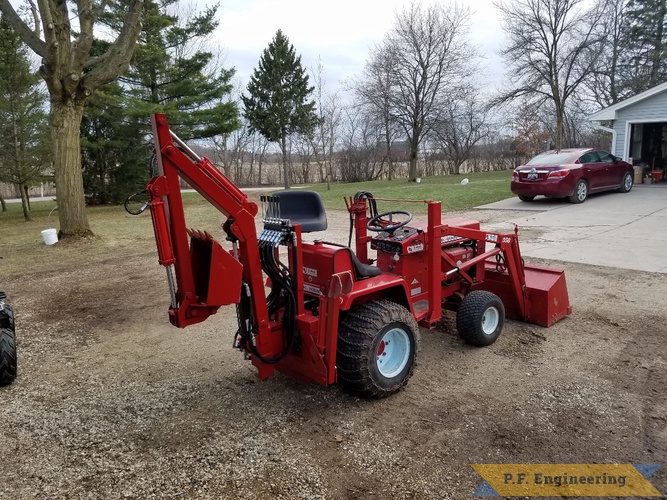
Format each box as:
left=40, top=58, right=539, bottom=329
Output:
left=432, top=88, right=490, bottom=174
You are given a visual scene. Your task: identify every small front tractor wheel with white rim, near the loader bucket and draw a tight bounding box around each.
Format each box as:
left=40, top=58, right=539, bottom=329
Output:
left=456, top=290, right=505, bottom=347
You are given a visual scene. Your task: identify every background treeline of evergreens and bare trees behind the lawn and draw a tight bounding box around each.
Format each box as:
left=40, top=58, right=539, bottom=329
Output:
left=0, top=0, right=667, bottom=222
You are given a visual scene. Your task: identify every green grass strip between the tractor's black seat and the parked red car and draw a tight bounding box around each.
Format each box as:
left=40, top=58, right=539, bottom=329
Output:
left=308, top=170, right=514, bottom=213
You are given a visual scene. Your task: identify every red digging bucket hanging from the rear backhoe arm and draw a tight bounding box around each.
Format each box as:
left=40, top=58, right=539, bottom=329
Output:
left=188, top=230, right=243, bottom=307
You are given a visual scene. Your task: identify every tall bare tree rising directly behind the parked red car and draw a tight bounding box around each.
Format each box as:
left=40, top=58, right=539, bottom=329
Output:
left=494, top=0, right=604, bottom=148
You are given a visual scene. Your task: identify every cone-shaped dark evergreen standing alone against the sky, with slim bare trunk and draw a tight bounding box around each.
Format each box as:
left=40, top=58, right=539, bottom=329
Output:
left=241, top=30, right=317, bottom=189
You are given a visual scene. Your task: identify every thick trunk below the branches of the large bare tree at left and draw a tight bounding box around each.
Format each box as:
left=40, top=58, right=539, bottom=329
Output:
left=50, top=101, right=93, bottom=239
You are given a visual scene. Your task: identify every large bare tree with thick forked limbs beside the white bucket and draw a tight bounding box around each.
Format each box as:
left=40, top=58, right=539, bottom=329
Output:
left=0, top=0, right=143, bottom=237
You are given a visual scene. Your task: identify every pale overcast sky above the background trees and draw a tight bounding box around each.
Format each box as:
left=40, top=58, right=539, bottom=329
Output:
left=215, top=0, right=503, bottom=95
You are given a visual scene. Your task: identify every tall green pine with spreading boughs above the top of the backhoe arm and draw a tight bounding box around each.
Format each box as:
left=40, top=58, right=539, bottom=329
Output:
left=120, top=0, right=239, bottom=139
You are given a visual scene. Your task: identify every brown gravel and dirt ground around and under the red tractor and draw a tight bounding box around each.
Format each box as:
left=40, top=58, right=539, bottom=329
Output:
left=0, top=211, right=667, bottom=499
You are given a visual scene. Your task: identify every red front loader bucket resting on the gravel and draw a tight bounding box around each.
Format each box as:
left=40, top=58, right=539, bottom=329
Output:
left=475, top=261, right=572, bottom=326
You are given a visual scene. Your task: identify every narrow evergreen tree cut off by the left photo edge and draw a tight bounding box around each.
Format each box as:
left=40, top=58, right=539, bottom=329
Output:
left=0, top=16, right=49, bottom=221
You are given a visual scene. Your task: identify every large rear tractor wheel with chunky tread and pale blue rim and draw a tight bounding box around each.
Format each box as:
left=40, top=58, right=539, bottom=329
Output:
left=336, top=300, right=419, bottom=398
